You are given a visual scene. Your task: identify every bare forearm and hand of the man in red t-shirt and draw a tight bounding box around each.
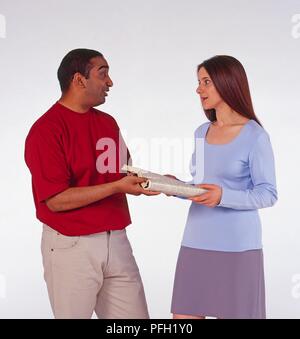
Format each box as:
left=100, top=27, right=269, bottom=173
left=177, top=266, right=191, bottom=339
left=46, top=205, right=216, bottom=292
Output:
left=46, top=176, right=150, bottom=212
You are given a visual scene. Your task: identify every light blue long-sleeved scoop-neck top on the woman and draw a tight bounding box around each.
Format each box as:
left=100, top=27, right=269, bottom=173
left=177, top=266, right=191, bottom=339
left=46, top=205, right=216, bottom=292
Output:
left=182, top=120, right=277, bottom=252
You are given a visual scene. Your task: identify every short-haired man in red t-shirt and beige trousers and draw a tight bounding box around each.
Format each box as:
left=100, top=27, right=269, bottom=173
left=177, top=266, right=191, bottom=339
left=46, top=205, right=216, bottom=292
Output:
left=25, top=49, right=156, bottom=318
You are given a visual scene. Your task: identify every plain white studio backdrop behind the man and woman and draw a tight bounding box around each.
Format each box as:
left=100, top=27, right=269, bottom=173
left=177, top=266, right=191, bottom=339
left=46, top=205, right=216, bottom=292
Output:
left=0, top=0, right=300, bottom=318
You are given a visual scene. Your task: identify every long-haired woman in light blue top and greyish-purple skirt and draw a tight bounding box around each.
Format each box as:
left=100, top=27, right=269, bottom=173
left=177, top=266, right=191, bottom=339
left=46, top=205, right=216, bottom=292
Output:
left=171, top=55, right=277, bottom=319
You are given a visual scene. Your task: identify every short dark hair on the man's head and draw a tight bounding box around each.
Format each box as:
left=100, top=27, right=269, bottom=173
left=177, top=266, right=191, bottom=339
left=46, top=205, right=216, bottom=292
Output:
left=57, top=48, right=103, bottom=93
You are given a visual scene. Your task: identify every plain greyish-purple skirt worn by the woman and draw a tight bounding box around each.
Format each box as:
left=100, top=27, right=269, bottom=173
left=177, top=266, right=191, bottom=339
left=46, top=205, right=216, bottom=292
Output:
left=171, top=246, right=266, bottom=319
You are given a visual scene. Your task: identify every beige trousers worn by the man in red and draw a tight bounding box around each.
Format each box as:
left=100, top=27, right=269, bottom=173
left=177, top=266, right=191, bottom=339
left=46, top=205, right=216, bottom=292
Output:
left=42, top=224, right=149, bottom=319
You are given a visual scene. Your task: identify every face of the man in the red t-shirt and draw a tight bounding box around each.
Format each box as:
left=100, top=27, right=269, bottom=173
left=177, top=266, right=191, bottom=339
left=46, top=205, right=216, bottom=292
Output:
left=85, top=57, right=113, bottom=107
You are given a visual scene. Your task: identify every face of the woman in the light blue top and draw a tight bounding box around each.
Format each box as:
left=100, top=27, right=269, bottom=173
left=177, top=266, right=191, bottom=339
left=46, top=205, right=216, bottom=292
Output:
left=196, top=67, right=224, bottom=110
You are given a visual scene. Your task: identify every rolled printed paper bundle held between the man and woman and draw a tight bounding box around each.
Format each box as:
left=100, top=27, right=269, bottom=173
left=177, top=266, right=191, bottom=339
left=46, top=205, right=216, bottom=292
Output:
left=122, top=165, right=207, bottom=198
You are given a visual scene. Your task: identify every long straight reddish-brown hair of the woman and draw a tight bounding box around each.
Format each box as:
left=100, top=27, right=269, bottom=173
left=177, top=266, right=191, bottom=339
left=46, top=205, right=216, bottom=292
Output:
left=197, top=55, right=261, bottom=125
